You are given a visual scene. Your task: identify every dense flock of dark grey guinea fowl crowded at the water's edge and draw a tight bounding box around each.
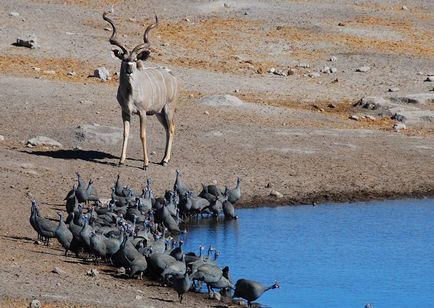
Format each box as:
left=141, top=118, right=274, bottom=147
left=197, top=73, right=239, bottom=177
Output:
left=30, top=170, right=279, bottom=306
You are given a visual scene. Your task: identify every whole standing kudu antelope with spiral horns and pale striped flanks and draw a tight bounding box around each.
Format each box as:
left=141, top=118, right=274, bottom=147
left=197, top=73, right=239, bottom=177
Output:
left=103, top=12, right=178, bottom=169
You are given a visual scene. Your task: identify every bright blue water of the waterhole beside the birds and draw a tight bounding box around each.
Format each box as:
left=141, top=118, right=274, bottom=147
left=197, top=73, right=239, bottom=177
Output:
left=181, top=199, right=434, bottom=308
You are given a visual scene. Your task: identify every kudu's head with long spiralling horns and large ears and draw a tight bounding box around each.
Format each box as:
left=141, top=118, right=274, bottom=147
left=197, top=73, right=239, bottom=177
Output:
left=102, top=12, right=158, bottom=76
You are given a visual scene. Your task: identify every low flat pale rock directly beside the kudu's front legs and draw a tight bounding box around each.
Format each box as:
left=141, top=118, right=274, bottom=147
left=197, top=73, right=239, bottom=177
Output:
left=75, top=124, right=123, bottom=145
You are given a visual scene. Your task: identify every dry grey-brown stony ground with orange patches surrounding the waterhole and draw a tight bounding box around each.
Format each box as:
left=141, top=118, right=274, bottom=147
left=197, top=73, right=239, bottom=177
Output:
left=0, top=0, right=434, bottom=307
